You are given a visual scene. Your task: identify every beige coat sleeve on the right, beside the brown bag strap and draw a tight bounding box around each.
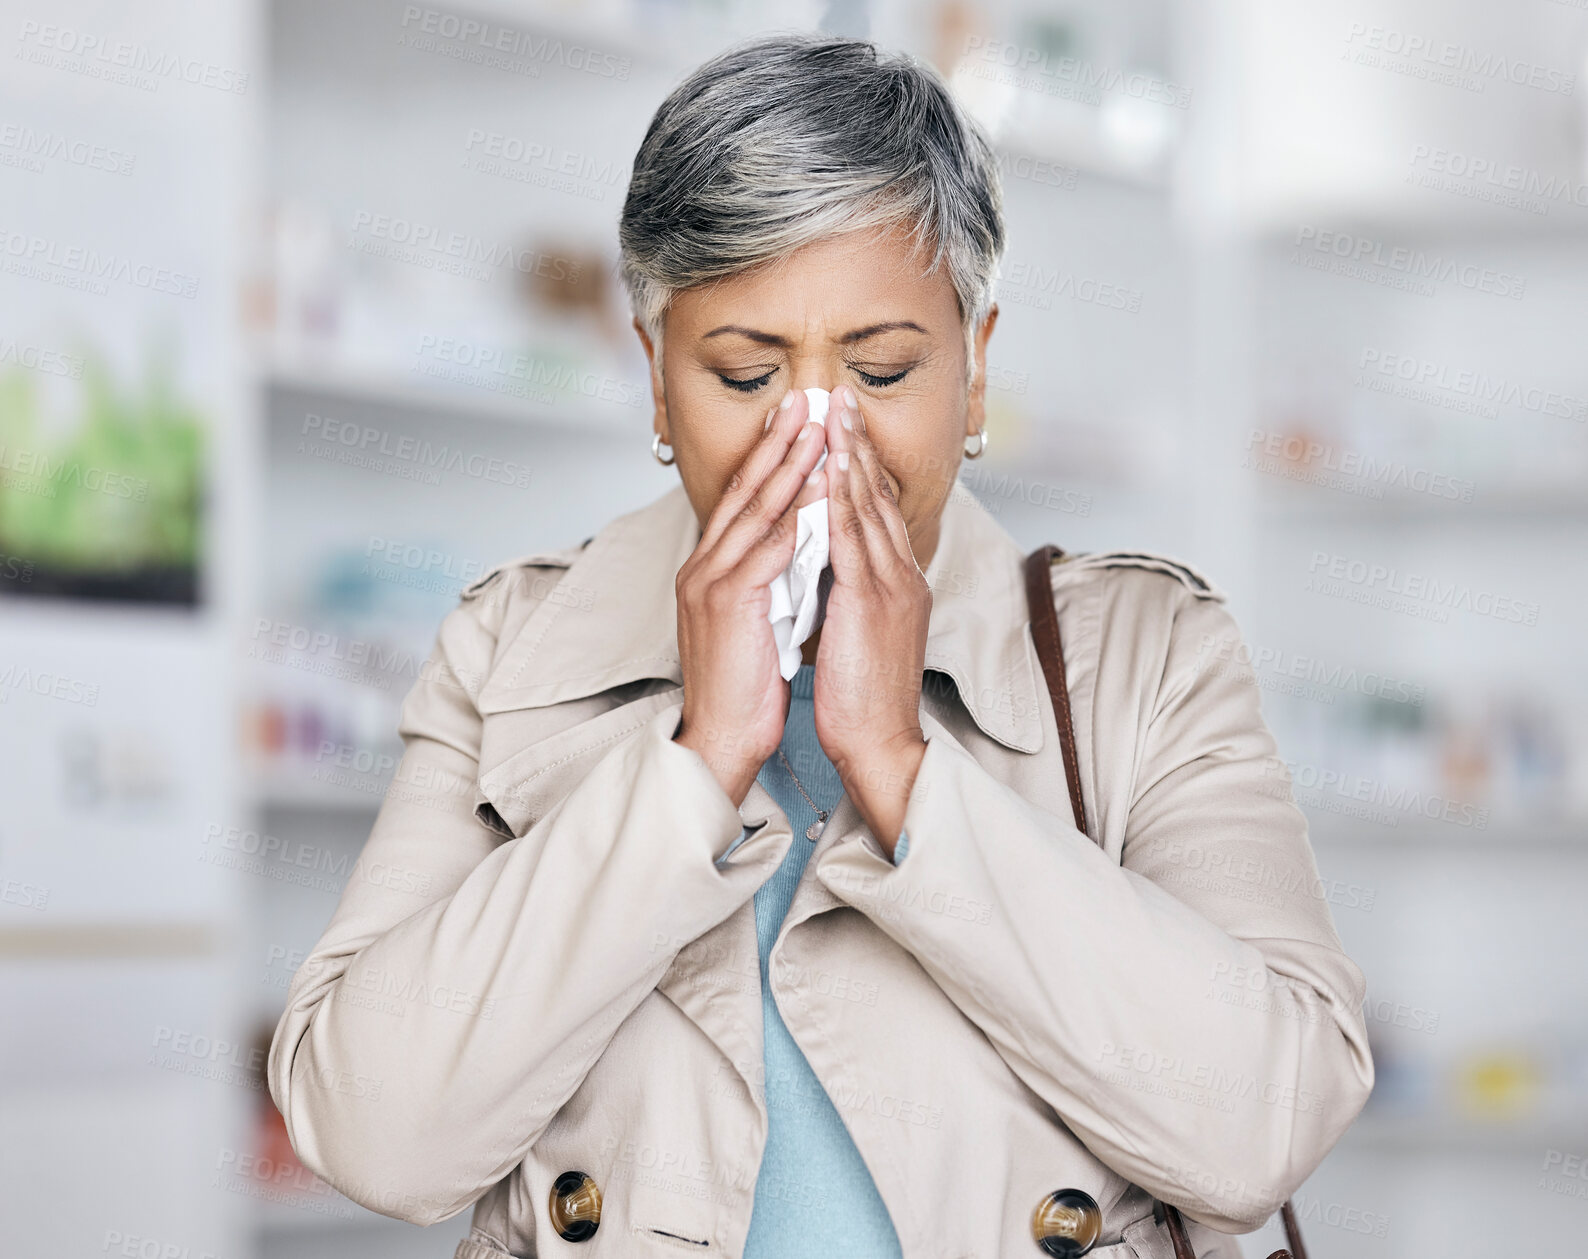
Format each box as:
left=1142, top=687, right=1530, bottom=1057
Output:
left=823, top=581, right=1374, bottom=1232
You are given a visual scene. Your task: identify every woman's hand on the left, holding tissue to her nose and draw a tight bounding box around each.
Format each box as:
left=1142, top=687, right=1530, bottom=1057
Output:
left=673, top=391, right=827, bottom=808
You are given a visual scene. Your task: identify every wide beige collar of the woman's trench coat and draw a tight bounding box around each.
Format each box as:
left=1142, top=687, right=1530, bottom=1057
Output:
left=478, top=484, right=1043, bottom=753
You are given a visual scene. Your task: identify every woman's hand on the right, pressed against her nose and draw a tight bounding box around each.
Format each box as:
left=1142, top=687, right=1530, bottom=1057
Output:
left=815, top=386, right=932, bottom=857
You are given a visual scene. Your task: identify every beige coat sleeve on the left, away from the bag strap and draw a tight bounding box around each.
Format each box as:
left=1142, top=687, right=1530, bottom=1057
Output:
left=267, top=584, right=800, bottom=1224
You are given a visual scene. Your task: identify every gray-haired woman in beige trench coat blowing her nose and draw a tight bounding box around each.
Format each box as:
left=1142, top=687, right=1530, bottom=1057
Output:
left=270, top=37, right=1374, bottom=1259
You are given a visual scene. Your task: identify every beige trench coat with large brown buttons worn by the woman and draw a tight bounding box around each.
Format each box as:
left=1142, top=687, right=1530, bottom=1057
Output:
left=268, top=476, right=1374, bottom=1259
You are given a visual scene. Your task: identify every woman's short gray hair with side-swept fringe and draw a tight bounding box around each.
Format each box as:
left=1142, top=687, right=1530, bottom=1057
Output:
left=618, top=33, right=1005, bottom=383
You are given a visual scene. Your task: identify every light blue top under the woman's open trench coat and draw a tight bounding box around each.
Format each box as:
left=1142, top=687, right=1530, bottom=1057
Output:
left=720, top=665, right=907, bottom=1259
